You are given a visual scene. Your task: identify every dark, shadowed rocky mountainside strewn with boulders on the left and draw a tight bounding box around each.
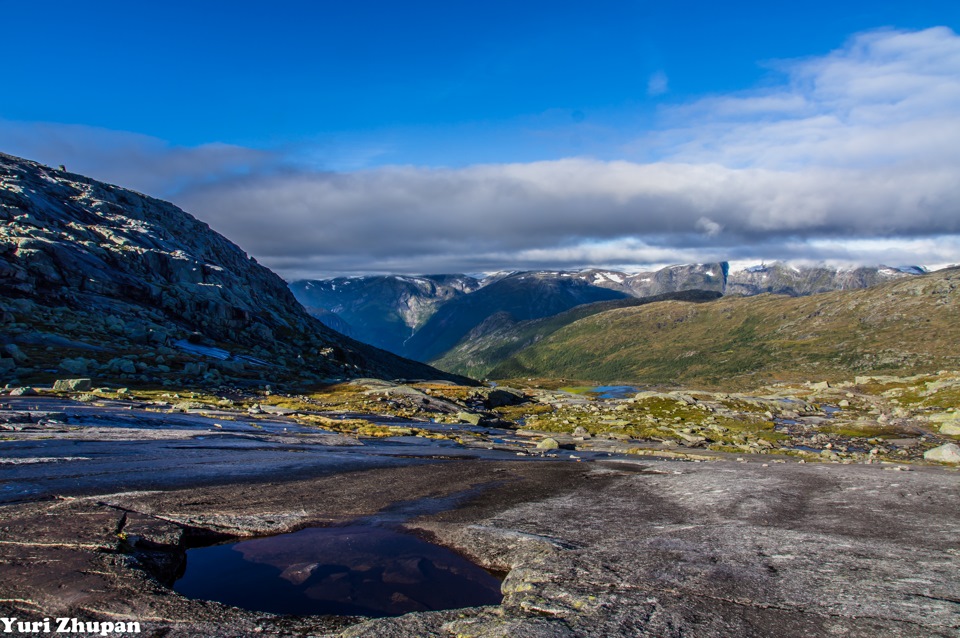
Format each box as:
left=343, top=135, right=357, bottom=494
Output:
left=0, top=154, right=464, bottom=382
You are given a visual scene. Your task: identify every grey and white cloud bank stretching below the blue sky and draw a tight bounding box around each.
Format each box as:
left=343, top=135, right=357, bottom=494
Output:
left=0, top=28, right=960, bottom=279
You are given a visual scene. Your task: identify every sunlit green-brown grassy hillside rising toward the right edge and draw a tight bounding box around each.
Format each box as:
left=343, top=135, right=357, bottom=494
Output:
left=489, top=269, right=960, bottom=387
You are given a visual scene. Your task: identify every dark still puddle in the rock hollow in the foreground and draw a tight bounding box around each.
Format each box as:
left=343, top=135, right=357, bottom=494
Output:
left=174, top=525, right=502, bottom=617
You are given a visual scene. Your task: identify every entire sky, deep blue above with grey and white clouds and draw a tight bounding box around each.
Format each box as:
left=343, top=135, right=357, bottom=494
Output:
left=0, top=0, right=960, bottom=278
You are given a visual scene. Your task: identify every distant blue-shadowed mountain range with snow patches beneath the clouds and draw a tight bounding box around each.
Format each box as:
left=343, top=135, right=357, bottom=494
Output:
left=290, top=262, right=925, bottom=376
